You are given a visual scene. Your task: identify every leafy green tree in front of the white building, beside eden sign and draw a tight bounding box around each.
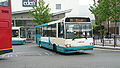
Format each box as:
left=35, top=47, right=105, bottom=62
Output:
left=29, top=0, right=52, bottom=25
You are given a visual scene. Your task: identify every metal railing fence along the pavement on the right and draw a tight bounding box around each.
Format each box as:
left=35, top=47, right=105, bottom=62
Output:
left=93, top=35, right=120, bottom=47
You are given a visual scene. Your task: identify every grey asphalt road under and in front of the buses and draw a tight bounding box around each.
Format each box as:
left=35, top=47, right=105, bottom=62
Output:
left=0, top=43, right=120, bottom=68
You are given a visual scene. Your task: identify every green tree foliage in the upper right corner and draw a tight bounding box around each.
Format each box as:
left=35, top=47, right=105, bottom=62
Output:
left=89, top=0, right=120, bottom=24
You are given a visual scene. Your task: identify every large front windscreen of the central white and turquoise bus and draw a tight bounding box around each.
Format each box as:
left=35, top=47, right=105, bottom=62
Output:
left=66, top=23, right=92, bottom=39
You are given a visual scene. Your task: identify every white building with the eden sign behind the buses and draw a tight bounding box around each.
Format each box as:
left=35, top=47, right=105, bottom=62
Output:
left=12, top=0, right=94, bottom=39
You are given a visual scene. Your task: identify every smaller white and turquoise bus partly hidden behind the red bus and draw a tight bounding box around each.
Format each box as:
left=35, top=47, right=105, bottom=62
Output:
left=12, top=27, right=26, bottom=45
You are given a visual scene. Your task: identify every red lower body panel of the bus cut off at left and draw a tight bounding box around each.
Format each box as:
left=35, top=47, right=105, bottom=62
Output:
left=0, top=21, right=12, bottom=54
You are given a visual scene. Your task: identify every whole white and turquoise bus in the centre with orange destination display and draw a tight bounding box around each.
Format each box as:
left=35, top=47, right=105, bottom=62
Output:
left=35, top=17, right=93, bottom=53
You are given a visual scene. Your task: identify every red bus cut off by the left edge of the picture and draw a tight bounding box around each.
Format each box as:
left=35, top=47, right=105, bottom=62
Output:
left=0, top=0, right=13, bottom=55
